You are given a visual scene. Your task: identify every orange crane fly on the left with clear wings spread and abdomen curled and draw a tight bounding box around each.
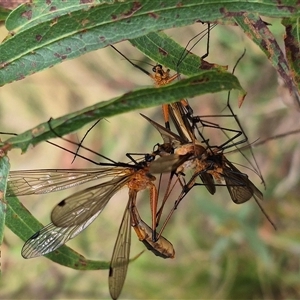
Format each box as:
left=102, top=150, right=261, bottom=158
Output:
left=7, top=120, right=175, bottom=299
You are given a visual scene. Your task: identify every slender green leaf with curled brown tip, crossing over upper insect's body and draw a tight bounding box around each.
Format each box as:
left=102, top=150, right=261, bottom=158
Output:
left=0, top=71, right=245, bottom=152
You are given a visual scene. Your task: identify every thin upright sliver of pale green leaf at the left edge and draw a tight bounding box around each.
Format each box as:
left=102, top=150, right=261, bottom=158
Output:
left=0, top=152, right=10, bottom=274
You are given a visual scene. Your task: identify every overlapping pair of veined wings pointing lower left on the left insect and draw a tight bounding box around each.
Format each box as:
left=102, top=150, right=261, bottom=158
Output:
left=22, top=176, right=129, bottom=258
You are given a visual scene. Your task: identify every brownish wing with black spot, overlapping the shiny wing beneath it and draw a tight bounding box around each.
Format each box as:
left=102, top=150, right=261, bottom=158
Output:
left=51, top=175, right=130, bottom=227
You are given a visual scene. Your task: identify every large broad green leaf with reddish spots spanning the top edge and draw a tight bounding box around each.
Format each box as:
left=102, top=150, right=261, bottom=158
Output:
left=0, top=0, right=300, bottom=85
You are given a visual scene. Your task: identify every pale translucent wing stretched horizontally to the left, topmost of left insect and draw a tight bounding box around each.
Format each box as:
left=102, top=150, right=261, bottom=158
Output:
left=6, top=166, right=126, bottom=196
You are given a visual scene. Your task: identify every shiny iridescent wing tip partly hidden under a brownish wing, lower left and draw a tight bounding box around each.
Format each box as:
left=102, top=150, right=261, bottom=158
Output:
left=21, top=211, right=100, bottom=258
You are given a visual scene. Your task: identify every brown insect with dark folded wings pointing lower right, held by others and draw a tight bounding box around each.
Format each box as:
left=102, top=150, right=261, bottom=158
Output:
left=145, top=110, right=276, bottom=236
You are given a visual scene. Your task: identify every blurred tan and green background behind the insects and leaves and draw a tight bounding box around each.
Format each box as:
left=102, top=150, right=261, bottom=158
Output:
left=0, top=20, right=300, bottom=299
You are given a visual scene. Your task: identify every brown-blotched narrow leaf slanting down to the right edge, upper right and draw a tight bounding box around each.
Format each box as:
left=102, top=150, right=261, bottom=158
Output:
left=235, top=14, right=300, bottom=105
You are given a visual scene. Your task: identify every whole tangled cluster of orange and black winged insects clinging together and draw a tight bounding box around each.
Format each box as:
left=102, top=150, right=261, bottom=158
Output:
left=4, top=25, right=268, bottom=299
